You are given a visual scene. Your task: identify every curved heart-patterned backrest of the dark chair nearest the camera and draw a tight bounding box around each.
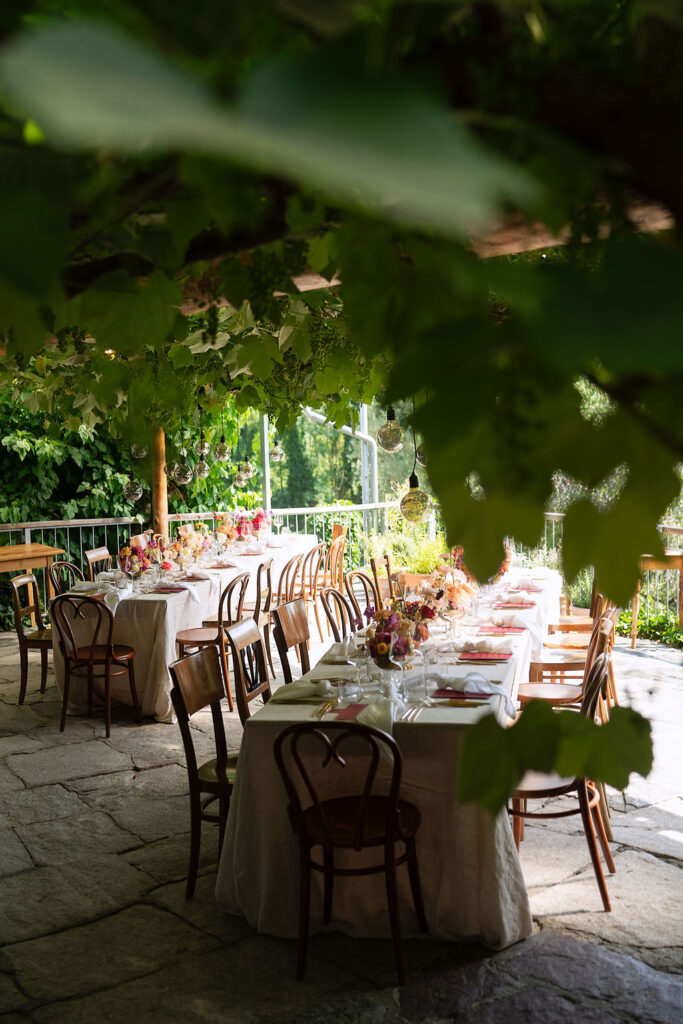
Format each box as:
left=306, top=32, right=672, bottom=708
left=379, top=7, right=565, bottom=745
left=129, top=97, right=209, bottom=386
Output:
left=273, top=722, right=402, bottom=850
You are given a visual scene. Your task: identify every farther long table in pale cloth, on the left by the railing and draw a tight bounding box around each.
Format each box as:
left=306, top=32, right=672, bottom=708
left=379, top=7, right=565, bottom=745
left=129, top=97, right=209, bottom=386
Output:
left=53, top=534, right=317, bottom=722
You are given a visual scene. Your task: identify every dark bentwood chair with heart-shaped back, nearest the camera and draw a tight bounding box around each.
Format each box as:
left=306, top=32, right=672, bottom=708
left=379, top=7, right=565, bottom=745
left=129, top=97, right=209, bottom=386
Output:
left=274, top=722, right=427, bottom=985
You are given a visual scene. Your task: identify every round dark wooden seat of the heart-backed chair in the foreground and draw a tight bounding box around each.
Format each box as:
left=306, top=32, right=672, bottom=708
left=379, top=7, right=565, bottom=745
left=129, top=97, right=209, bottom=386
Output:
left=304, top=797, right=421, bottom=848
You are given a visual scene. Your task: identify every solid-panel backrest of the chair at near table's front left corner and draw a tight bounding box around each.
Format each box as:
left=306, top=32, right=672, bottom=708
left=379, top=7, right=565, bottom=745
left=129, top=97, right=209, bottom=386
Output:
left=169, top=646, right=227, bottom=784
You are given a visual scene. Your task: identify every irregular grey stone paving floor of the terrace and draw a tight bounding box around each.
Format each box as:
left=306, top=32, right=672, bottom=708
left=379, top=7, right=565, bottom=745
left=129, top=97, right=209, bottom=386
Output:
left=0, top=634, right=683, bottom=1024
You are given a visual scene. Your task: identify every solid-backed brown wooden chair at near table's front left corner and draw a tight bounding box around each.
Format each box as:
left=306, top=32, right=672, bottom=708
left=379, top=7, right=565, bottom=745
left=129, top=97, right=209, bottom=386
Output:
left=170, top=646, right=237, bottom=899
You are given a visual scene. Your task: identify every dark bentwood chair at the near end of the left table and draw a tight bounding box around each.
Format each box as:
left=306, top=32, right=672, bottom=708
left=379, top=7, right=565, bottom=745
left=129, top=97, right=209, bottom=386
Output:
left=52, top=594, right=140, bottom=737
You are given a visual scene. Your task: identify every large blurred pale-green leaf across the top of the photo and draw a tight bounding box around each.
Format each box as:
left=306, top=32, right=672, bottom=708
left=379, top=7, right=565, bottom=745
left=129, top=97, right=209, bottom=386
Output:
left=0, top=22, right=531, bottom=236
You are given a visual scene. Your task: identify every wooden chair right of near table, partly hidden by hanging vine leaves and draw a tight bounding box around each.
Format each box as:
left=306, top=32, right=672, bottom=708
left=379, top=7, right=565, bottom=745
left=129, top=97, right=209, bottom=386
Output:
left=508, top=654, right=616, bottom=910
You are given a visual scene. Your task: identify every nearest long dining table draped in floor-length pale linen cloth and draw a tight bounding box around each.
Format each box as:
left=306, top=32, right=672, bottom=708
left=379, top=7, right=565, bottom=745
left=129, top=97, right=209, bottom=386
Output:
left=216, top=574, right=559, bottom=948
